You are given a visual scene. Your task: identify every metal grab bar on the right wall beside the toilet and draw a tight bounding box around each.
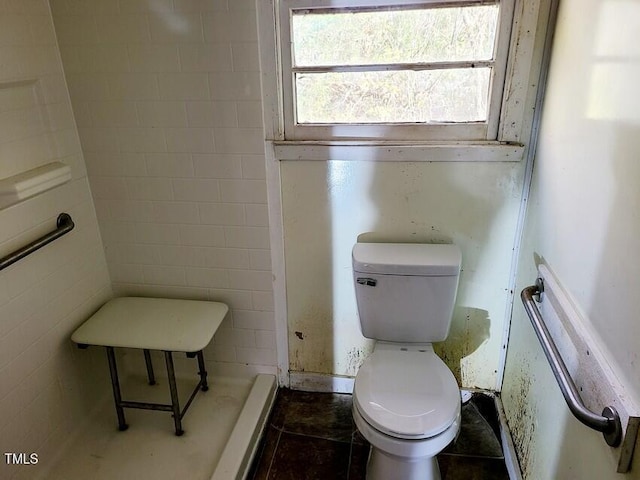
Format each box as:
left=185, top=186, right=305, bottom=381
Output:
left=520, top=278, right=622, bottom=447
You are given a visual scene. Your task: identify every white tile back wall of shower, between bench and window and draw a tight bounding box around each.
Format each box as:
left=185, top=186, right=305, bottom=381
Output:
left=51, top=0, right=276, bottom=376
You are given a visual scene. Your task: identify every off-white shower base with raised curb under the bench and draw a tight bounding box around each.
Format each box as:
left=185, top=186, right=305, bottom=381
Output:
left=26, top=375, right=276, bottom=480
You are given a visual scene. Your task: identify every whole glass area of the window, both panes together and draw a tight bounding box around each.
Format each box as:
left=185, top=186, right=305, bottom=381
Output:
left=290, top=4, right=498, bottom=125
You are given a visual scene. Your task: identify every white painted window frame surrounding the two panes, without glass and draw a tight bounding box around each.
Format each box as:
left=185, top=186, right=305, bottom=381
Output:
left=275, top=0, right=515, bottom=142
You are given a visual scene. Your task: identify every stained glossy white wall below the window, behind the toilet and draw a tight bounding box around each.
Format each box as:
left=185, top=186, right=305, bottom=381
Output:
left=281, top=161, right=524, bottom=389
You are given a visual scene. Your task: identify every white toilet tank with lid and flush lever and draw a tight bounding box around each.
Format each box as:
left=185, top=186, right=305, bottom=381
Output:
left=352, top=243, right=462, bottom=343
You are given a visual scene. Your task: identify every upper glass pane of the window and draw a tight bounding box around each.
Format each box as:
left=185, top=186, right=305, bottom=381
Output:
left=292, top=5, right=498, bottom=67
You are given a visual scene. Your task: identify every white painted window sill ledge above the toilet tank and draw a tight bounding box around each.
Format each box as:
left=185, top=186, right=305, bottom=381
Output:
left=273, top=140, right=524, bottom=162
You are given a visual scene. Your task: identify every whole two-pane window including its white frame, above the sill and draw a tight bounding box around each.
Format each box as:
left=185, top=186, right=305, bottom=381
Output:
left=279, top=0, right=513, bottom=141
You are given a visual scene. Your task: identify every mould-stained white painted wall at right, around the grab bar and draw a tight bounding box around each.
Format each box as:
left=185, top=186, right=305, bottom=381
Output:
left=503, top=0, right=640, bottom=474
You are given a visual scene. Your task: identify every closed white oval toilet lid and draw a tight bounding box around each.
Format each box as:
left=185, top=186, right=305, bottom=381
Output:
left=354, top=349, right=460, bottom=439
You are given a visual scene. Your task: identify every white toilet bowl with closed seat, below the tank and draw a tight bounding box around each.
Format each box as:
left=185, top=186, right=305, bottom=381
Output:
left=353, top=342, right=461, bottom=480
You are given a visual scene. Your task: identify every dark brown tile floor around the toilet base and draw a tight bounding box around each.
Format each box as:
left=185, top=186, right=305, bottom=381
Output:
left=249, top=389, right=509, bottom=480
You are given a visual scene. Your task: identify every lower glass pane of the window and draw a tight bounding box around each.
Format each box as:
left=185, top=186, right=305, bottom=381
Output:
left=295, top=68, right=491, bottom=123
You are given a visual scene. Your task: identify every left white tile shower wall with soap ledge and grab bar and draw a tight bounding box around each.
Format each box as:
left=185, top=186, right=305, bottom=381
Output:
left=0, top=0, right=115, bottom=478
